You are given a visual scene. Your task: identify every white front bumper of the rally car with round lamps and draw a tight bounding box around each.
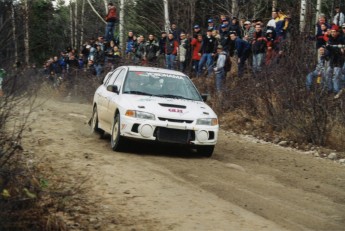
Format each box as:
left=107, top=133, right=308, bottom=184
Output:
left=120, top=115, right=219, bottom=145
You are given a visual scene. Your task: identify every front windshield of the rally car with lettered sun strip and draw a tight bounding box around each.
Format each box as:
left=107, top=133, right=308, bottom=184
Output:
left=123, top=71, right=202, bottom=101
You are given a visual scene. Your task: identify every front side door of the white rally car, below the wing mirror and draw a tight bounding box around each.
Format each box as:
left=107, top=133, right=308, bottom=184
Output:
left=106, top=69, right=127, bottom=124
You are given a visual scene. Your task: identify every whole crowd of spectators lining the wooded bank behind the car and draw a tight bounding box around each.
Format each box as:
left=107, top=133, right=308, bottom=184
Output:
left=41, top=7, right=345, bottom=94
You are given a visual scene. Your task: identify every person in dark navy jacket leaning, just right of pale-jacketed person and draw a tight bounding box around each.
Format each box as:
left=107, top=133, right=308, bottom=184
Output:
left=230, top=32, right=250, bottom=78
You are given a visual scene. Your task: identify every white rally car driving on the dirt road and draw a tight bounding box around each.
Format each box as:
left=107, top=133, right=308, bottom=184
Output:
left=90, top=66, right=219, bottom=157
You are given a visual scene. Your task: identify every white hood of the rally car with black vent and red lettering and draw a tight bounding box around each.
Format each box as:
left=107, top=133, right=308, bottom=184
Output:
left=123, top=95, right=217, bottom=120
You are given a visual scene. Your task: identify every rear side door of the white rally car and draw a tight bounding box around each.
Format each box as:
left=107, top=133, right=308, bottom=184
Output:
left=98, top=69, right=122, bottom=128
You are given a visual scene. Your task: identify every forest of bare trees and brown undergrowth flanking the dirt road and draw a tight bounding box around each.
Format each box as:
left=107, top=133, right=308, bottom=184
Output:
left=0, top=0, right=345, bottom=230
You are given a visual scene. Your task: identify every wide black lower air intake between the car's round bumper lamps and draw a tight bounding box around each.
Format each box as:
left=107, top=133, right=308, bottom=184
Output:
left=156, top=127, right=195, bottom=144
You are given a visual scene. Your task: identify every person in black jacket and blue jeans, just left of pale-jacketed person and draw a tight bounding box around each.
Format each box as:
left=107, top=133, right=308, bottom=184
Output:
left=197, top=27, right=217, bottom=76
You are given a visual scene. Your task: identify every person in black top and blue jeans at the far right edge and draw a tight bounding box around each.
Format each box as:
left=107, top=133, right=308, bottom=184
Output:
left=326, top=25, right=345, bottom=94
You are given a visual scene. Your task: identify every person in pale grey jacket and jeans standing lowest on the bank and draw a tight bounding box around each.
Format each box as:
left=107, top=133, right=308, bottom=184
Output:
left=213, top=45, right=227, bottom=92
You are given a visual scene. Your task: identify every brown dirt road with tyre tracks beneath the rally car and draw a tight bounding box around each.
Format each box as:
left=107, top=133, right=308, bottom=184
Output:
left=23, top=100, right=345, bottom=231
